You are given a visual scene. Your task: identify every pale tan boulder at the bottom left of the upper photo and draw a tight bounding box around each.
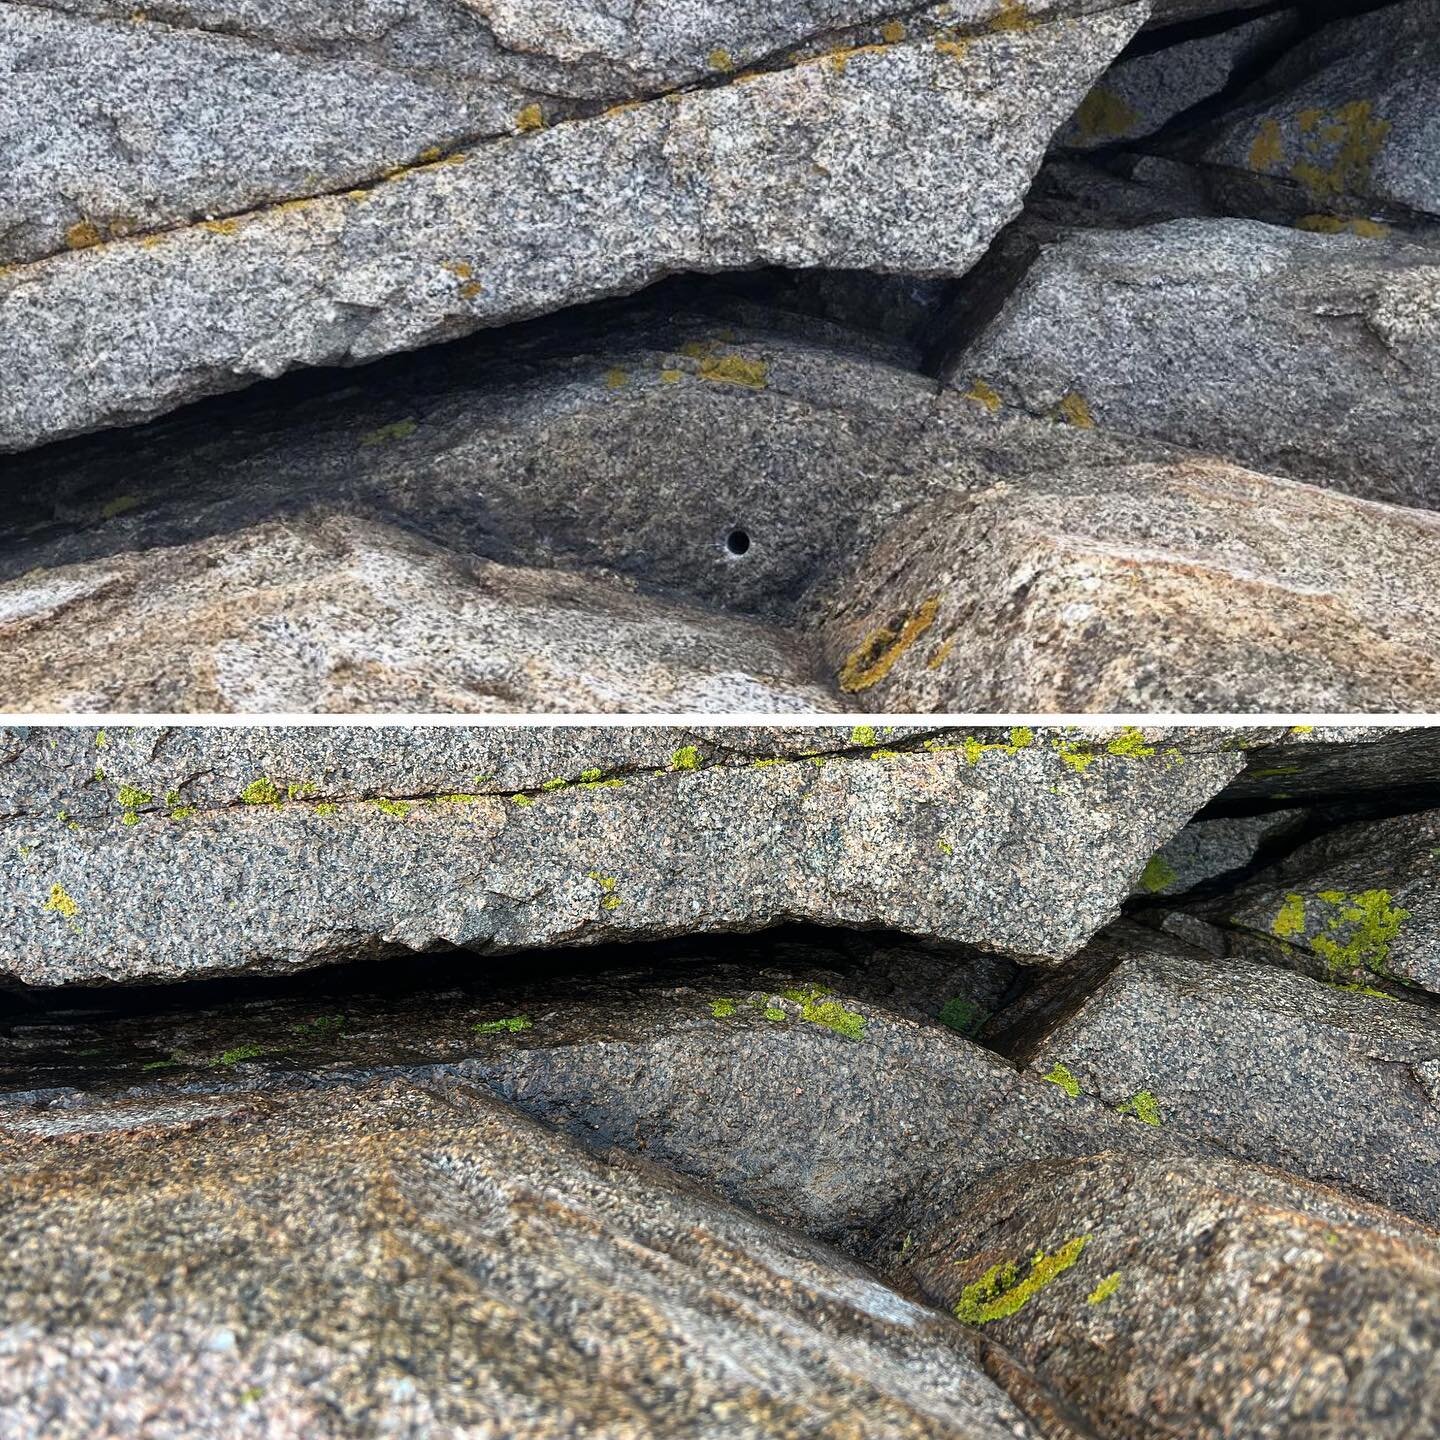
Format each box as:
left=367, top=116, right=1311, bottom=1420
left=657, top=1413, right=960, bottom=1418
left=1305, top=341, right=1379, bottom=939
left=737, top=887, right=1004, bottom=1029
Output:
left=0, top=510, right=840, bottom=714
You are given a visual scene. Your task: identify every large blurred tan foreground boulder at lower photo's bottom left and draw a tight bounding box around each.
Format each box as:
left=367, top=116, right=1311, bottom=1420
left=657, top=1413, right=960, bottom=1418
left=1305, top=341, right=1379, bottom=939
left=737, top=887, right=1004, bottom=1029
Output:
left=0, top=1081, right=1040, bottom=1440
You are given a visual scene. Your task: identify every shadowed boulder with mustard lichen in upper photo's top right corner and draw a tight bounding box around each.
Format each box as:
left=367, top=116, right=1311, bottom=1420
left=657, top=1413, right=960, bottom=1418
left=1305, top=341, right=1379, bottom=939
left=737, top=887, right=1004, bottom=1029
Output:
left=1176, top=0, right=1440, bottom=225
